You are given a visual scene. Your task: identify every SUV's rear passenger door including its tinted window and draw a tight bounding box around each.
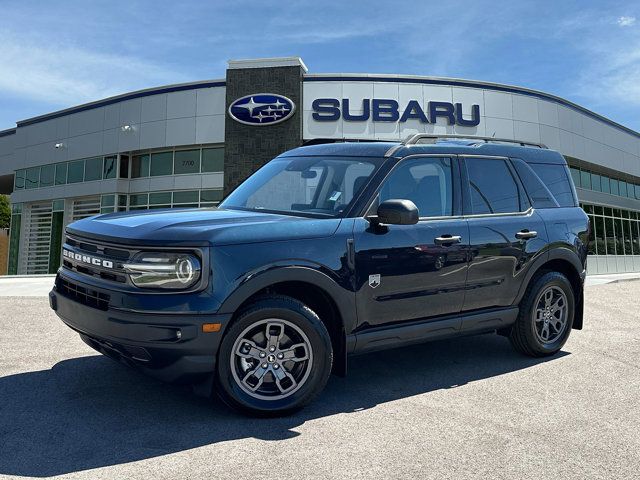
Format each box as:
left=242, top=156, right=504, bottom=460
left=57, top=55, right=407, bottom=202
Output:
left=461, top=156, right=547, bottom=311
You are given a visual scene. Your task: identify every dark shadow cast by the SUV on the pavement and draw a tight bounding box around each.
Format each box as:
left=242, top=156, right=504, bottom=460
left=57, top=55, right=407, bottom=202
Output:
left=0, top=335, right=568, bottom=477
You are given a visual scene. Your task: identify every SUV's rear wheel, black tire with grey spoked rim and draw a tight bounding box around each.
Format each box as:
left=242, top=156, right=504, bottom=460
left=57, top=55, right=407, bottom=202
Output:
left=509, top=272, right=575, bottom=357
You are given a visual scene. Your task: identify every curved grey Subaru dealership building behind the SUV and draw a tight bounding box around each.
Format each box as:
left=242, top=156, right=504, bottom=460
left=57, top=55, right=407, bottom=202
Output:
left=0, top=58, right=640, bottom=274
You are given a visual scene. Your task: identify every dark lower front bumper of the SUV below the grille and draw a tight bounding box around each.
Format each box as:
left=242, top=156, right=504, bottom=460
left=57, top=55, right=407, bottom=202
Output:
left=49, top=277, right=231, bottom=383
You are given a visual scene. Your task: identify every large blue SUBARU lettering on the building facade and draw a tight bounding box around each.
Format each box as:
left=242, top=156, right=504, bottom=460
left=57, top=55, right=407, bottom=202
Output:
left=311, top=98, right=480, bottom=127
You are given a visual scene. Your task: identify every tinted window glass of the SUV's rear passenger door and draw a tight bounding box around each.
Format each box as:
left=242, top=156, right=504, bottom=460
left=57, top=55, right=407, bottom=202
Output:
left=465, top=158, right=525, bottom=214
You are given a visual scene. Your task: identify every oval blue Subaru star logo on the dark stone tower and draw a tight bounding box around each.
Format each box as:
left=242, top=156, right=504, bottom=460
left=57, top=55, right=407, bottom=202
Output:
left=229, top=93, right=296, bottom=125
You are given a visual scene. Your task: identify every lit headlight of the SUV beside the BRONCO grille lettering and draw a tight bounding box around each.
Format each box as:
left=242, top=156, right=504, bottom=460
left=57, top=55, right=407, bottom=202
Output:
left=124, top=252, right=200, bottom=290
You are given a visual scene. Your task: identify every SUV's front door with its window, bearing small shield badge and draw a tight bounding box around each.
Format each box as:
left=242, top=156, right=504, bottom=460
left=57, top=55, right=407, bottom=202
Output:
left=354, top=157, right=469, bottom=329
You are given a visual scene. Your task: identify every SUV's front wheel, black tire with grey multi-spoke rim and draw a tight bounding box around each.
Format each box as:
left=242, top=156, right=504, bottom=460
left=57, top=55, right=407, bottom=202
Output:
left=216, top=295, right=333, bottom=416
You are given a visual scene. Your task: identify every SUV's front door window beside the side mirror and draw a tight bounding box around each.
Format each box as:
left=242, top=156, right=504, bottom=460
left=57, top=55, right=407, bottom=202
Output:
left=378, top=158, right=453, bottom=217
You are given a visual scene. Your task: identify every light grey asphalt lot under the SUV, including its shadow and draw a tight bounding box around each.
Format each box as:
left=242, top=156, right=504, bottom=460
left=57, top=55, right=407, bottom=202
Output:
left=0, top=281, right=640, bottom=480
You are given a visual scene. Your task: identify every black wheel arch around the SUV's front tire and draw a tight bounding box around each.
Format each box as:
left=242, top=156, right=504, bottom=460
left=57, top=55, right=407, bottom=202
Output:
left=232, top=281, right=346, bottom=375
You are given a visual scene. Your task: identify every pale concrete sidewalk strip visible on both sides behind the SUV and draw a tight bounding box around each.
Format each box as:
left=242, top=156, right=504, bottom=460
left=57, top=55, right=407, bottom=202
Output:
left=0, top=272, right=640, bottom=297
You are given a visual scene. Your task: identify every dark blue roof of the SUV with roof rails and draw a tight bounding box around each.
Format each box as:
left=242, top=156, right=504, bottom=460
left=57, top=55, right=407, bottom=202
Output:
left=280, top=139, right=566, bottom=165
